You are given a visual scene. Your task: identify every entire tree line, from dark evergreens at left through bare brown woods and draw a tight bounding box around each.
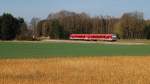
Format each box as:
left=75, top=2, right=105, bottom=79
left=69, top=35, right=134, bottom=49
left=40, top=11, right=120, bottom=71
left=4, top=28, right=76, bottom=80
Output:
left=0, top=10, right=150, bottom=40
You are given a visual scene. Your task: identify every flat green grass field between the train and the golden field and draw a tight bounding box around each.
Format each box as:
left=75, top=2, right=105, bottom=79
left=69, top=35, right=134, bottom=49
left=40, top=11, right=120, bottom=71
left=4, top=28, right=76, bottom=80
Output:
left=0, top=42, right=150, bottom=58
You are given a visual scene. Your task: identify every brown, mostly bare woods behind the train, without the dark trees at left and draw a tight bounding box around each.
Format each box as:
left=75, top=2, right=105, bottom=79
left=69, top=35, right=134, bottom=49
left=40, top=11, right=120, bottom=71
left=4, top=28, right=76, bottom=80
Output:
left=36, top=11, right=150, bottom=39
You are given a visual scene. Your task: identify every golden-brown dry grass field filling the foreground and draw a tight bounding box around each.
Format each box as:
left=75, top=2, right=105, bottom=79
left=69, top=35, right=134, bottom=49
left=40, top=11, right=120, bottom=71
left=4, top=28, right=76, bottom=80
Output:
left=0, top=57, right=150, bottom=84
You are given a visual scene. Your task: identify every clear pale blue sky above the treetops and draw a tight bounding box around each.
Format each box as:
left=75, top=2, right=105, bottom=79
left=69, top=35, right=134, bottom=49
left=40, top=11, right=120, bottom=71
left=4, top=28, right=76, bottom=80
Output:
left=0, top=0, right=150, bottom=22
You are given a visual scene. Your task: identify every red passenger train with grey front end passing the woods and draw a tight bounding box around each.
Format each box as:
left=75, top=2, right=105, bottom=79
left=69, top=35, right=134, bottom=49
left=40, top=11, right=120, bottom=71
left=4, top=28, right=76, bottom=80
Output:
left=70, top=34, right=117, bottom=41
